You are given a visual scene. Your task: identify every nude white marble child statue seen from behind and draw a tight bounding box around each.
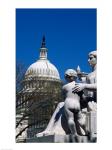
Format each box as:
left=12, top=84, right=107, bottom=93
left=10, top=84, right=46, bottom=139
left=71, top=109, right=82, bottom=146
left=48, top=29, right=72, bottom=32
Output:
left=63, top=69, right=85, bottom=136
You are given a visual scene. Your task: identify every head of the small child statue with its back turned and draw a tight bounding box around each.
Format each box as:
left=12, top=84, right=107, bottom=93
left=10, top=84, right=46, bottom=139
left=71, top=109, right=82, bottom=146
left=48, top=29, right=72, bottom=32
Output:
left=65, top=69, right=77, bottom=81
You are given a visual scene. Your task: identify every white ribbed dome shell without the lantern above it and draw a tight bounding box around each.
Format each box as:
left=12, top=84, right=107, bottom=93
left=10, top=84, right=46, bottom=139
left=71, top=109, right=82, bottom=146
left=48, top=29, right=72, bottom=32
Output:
left=25, top=59, right=60, bottom=80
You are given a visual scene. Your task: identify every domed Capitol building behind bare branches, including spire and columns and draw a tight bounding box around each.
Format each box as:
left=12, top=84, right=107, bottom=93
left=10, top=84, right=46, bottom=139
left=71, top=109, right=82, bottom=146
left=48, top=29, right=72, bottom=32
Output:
left=16, top=36, right=63, bottom=142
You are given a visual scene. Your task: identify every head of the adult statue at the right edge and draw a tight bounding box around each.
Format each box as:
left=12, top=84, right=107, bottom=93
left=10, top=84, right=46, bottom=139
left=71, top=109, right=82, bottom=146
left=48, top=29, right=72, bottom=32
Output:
left=88, top=51, right=97, bottom=67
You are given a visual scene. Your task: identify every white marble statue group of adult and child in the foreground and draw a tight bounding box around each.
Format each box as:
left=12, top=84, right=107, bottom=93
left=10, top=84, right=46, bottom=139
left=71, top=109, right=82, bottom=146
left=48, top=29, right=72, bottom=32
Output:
left=37, top=51, right=97, bottom=142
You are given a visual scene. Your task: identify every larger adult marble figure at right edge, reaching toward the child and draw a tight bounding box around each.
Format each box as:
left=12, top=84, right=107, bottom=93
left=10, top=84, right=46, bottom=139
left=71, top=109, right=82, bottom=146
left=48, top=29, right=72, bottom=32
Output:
left=73, top=51, right=97, bottom=111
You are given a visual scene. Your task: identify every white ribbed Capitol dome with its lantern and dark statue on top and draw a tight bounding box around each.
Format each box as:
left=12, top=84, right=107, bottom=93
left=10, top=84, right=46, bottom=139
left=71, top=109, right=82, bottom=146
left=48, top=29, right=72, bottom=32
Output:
left=25, top=37, right=60, bottom=80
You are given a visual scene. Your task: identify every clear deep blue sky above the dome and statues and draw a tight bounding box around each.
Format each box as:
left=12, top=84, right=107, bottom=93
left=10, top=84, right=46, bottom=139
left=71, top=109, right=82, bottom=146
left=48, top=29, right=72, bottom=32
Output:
left=16, top=9, right=97, bottom=79
